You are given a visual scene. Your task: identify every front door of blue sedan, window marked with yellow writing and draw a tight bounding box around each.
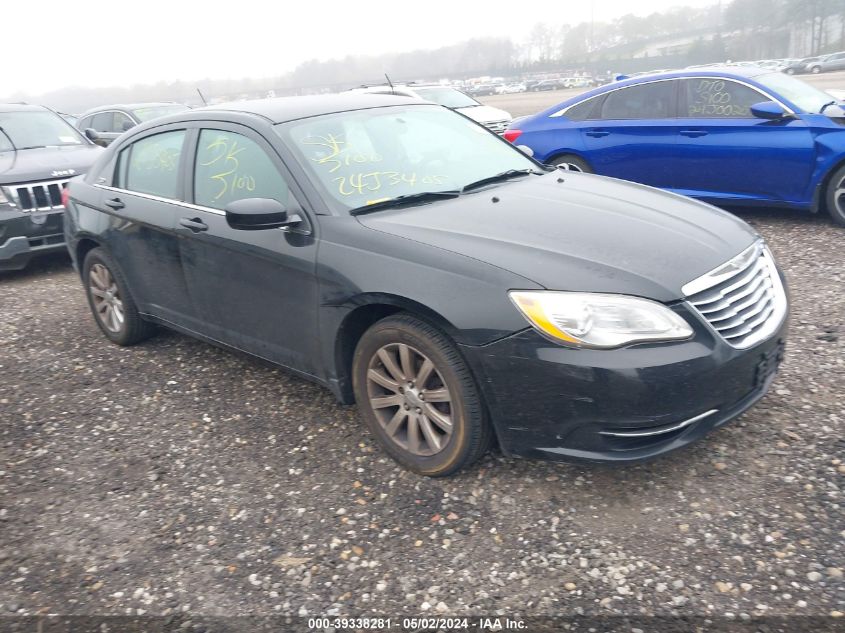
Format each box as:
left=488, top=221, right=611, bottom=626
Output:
left=672, top=77, right=815, bottom=202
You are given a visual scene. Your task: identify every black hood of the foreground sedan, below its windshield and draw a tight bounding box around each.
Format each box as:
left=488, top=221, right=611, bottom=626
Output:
left=359, top=172, right=757, bottom=301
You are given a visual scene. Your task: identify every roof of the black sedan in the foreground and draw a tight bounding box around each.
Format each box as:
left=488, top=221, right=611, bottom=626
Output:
left=191, top=92, right=431, bottom=123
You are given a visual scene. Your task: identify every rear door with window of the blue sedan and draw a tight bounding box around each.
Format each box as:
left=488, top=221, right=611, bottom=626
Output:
left=579, top=79, right=678, bottom=187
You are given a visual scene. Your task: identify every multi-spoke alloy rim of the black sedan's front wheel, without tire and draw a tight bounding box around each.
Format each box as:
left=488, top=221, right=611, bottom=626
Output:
left=367, top=343, right=453, bottom=456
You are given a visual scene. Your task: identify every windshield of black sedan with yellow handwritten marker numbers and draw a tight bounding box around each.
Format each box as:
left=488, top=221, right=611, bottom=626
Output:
left=276, top=105, right=537, bottom=209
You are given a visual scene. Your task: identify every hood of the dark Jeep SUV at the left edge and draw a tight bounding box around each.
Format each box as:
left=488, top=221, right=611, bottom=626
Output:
left=0, top=144, right=104, bottom=185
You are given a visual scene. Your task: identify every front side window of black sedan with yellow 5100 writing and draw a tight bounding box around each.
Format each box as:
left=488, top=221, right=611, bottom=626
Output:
left=194, top=130, right=290, bottom=209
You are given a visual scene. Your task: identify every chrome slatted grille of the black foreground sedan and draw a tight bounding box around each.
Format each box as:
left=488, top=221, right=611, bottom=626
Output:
left=682, top=242, right=787, bottom=349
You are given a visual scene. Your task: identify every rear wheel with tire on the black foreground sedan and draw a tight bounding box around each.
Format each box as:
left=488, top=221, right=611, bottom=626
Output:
left=82, top=247, right=156, bottom=345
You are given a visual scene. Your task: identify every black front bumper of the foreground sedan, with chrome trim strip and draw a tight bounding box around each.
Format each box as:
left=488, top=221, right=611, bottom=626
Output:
left=463, top=306, right=787, bottom=462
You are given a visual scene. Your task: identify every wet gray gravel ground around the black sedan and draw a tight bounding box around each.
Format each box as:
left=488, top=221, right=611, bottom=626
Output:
left=0, top=211, right=845, bottom=630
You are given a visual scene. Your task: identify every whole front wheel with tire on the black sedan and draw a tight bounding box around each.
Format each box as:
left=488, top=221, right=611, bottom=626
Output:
left=352, top=314, right=493, bottom=477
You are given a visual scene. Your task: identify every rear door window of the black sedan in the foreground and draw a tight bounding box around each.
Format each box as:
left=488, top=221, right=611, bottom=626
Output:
left=117, top=130, right=185, bottom=198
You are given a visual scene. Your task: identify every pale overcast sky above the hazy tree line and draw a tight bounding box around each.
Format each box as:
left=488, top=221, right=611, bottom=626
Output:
left=8, top=0, right=716, bottom=95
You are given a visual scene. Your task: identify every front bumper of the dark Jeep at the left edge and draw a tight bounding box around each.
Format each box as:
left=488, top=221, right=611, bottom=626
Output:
left=0, top=205, right=66, bottom=271
